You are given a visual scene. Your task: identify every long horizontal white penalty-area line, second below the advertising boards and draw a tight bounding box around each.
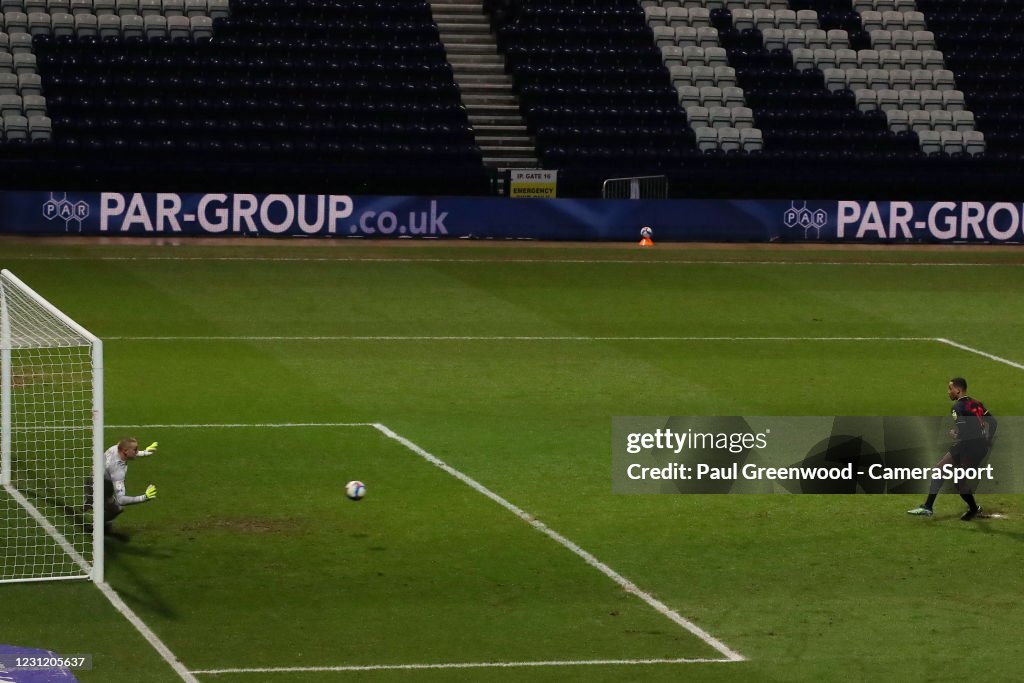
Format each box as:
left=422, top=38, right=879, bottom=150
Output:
left=103, top=335, right=935, bottom=342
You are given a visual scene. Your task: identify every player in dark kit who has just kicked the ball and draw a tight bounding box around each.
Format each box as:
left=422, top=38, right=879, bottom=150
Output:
left=906, top=377, right=997, bottom=521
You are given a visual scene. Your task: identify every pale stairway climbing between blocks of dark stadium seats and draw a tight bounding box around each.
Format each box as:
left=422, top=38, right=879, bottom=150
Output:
left=430, top=0, right=539, bottom=169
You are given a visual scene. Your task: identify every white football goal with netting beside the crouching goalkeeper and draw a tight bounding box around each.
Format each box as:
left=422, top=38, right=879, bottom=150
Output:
left=0, top=270, right=103, bottom=583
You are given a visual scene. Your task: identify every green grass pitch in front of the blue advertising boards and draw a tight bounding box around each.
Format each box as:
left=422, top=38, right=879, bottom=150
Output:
left=0, top=241, right=1024, bottom=683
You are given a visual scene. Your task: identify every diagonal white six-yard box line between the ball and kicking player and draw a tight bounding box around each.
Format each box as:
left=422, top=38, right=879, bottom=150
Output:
left=374, top=424, right=745, bottom=661
